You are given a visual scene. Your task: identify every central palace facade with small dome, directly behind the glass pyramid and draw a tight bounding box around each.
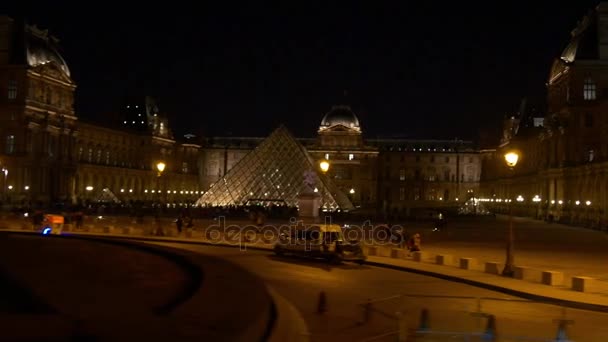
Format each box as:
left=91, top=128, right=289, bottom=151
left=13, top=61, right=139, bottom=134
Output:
left=201, top=105, right=481, bottom=217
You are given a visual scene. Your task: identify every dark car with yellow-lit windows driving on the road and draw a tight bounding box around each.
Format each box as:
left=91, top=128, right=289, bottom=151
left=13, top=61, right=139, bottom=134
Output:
left=274, top=224, right=367, bottom=265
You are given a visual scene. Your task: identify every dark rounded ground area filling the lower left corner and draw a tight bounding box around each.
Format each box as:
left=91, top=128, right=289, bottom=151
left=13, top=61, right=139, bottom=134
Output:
left=0, top=232, right=274, bottom=341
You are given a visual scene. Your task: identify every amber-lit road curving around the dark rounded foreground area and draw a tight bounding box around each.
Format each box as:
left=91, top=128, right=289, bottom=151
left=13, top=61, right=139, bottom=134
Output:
left=146, top=243, right=608, bottom=341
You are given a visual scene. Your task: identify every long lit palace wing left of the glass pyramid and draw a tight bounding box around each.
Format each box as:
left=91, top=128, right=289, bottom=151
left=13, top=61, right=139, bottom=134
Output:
left=0, top=16, right=200, bottom=205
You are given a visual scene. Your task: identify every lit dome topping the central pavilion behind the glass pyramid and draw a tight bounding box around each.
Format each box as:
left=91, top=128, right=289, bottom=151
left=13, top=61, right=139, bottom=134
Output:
left=318, top=105, right=363, bottom=147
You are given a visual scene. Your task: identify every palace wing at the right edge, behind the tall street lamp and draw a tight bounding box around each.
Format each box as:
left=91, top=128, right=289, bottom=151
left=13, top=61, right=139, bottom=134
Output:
left=482, top=3, right=608, bottom=227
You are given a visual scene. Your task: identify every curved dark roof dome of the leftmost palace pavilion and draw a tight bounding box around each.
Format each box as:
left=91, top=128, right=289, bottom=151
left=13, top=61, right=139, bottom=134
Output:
left=25, top=26, right=70, bottom=77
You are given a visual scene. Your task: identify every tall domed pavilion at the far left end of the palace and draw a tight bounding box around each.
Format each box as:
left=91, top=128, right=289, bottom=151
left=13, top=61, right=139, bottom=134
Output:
left=0, top=16, right=77, bottom=203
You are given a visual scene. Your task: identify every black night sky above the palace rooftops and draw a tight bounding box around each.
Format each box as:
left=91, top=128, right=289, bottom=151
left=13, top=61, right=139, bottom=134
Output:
left=6, top=0, right=598, bottom=138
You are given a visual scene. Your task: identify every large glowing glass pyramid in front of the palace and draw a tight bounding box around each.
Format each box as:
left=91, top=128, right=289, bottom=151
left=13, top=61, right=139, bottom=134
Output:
left=196, top=125, right=354, bottom=210
